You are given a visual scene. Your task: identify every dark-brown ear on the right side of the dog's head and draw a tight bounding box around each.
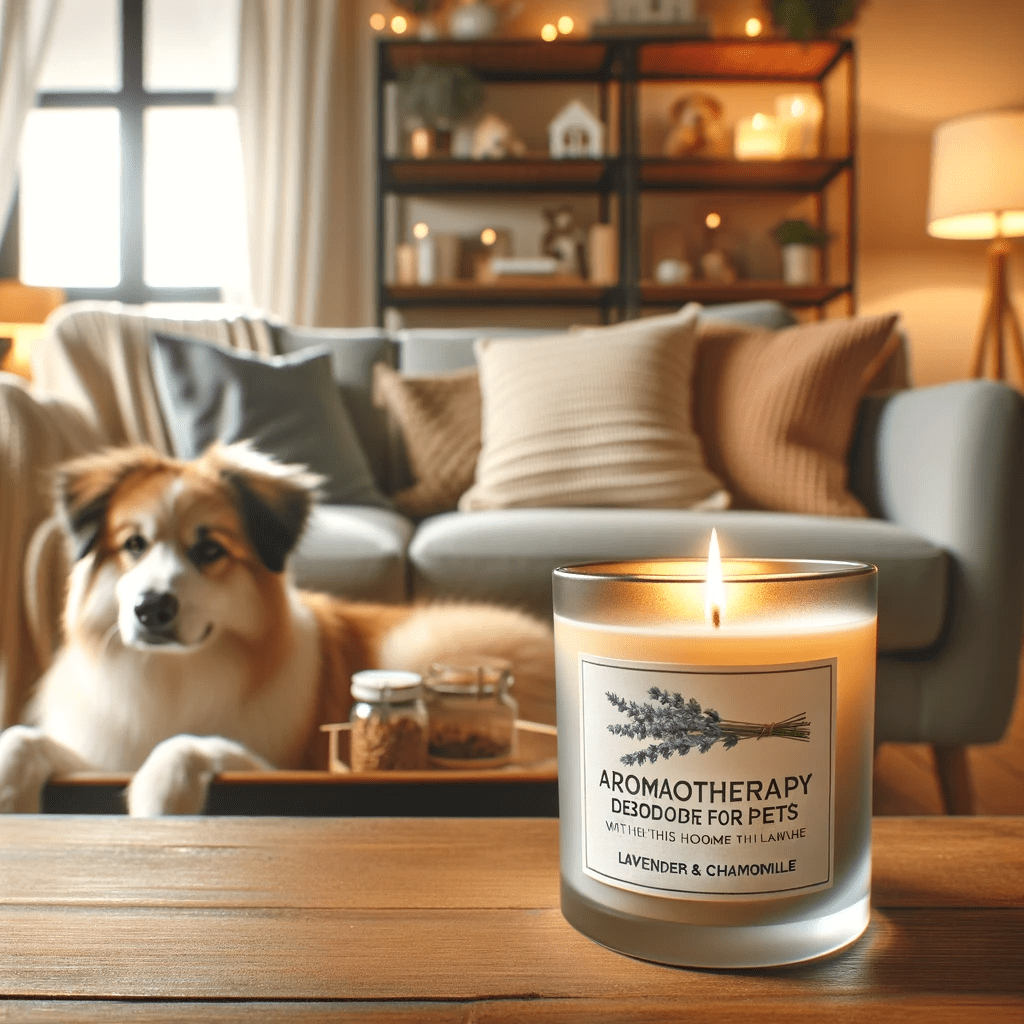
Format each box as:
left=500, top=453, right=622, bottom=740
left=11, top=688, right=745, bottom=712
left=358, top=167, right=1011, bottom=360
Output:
left=204, top=442, right=323, bottom=572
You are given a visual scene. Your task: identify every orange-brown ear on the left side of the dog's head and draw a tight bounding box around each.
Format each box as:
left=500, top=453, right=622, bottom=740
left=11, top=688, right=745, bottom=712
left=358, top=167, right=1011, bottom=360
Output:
left=53, top=447, right=166, bottom=561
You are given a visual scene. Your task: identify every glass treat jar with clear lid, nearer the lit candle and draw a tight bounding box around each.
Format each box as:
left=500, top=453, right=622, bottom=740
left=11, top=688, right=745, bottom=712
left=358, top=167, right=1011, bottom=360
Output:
left=426, top=655, right=519, bottom=768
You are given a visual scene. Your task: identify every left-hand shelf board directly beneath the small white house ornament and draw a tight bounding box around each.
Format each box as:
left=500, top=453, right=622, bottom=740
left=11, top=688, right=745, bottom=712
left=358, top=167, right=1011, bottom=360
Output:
left=384, top=157, right=611, bottom=194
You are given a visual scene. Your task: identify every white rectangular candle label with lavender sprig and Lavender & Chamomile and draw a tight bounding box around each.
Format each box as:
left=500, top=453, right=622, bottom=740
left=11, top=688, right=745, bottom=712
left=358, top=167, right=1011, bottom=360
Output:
left=579, top=654, right=837, bottom=900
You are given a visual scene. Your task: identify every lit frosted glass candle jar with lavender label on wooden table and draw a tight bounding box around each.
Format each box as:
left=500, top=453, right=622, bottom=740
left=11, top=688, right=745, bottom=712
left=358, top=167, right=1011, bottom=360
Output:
left=553, top=560, right=878, bottom=968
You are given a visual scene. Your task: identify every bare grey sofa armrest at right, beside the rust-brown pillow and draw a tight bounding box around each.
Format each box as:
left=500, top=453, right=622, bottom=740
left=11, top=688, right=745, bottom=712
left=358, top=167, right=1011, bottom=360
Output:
left=851, top=380, right=1024, bottom=742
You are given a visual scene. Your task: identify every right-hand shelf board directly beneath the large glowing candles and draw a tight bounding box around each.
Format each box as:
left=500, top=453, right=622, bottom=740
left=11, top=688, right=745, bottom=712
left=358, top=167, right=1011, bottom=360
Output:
left=640, top=157, right=851, bottom=190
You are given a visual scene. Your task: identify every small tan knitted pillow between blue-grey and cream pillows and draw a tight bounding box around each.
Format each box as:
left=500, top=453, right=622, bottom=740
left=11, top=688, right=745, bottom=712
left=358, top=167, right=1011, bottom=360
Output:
left=374, top=362, right=480, bottom=519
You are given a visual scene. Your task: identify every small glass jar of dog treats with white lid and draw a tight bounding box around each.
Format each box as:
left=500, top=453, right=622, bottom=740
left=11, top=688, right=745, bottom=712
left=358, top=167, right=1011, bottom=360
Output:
left=349, top=669, right=427, bottom=771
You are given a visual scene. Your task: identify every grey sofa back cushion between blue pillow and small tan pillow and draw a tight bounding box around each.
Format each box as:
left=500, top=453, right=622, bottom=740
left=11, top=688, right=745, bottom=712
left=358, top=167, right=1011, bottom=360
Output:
left=276, top=327, right=398, bottom=494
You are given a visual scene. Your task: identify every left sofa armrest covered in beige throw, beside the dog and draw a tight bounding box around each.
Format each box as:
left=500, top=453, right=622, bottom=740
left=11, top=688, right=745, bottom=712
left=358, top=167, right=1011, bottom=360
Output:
left=0, top=373, right=102, bottom=727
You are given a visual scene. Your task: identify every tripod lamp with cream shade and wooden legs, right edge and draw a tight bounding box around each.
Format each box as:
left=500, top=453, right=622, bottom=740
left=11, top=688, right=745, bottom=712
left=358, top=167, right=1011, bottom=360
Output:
left=928, top=110, right=1024, bottom=380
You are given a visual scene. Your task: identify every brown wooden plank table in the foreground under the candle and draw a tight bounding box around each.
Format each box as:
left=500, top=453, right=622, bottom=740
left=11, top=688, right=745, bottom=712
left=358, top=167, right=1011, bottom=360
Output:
left=0, top=815, right=1024, bottom=1024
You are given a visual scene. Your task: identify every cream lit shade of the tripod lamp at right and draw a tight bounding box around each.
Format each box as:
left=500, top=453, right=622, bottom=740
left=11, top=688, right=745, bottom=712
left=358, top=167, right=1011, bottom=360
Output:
left=928, top=111, right=1024, bottom=239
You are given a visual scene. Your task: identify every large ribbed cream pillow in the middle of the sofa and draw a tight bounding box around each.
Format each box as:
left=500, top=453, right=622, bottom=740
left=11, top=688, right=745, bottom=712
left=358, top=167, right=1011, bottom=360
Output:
left=459, top=309, right=729, bottom=511
